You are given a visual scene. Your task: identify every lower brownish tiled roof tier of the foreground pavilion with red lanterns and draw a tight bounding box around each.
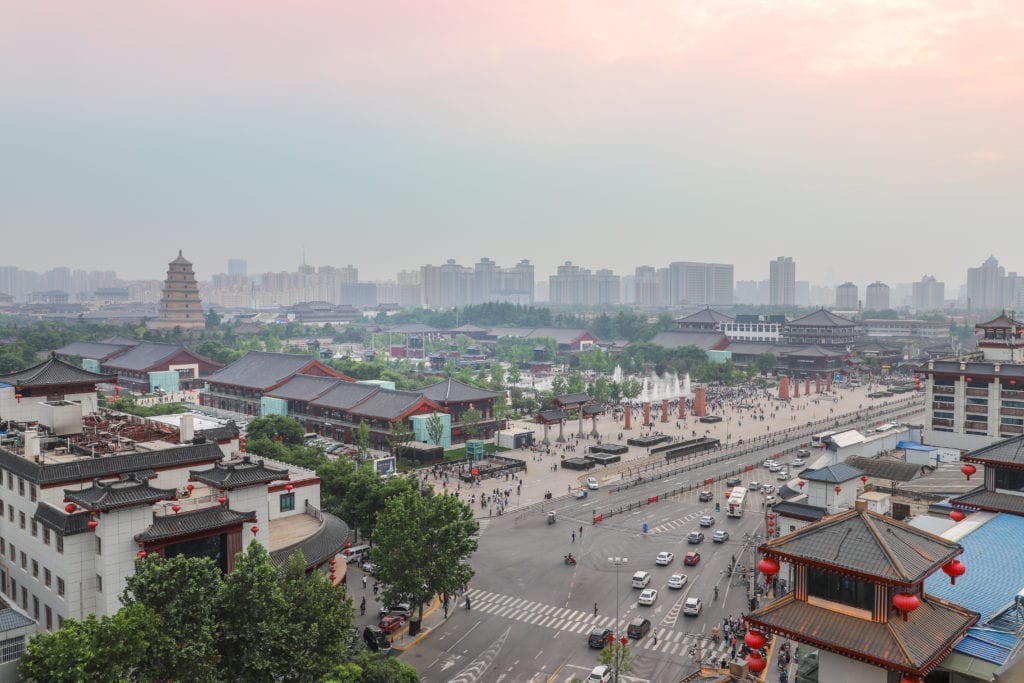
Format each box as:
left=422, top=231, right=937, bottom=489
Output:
left=746, top=593, right=978, bottom=672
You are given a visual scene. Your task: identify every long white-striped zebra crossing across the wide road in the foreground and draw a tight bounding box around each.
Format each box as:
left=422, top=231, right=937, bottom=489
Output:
left=468, top=589, right=730, bottom=659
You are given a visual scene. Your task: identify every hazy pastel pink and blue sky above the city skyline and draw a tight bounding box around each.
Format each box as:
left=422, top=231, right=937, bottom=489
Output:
left=0, top=0, right=1024, bottom=286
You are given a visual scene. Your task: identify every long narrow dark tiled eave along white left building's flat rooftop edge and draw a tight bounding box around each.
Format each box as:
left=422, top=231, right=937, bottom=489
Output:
left=0, top=443, right=224, bottom=484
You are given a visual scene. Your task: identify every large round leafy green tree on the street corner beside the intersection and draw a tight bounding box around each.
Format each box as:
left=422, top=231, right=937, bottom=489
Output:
left=370, top=490, right=480, bottom=620
